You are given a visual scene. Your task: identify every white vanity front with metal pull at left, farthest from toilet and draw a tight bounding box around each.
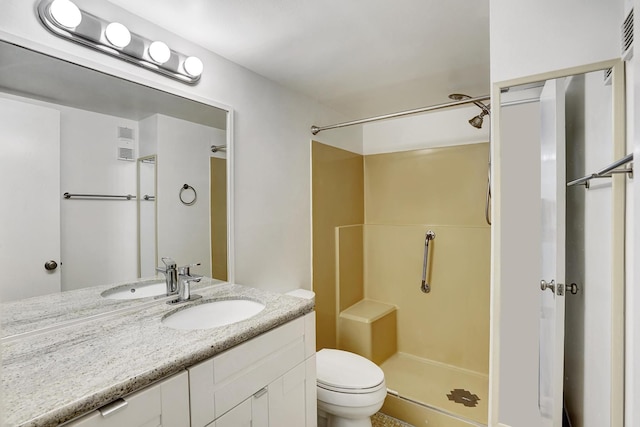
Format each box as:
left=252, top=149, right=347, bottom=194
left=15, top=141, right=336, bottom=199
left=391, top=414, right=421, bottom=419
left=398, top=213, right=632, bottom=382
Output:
left=65, top=371, right=189, bottom=427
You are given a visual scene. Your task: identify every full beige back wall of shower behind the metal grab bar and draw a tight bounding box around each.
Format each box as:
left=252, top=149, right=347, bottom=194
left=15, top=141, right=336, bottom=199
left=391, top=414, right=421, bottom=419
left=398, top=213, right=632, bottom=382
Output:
left=364, top=143, right=491, bottom=373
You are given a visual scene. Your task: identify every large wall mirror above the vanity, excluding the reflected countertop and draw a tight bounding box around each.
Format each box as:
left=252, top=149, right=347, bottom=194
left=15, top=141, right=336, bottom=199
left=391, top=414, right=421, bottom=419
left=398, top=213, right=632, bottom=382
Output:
left=0, top=42, right=230, bottom=302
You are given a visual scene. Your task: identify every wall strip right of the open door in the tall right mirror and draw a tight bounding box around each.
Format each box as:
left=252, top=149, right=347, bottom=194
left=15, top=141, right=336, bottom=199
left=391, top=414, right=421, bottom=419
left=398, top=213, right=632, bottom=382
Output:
left=564, top=72, right=614, bottom=427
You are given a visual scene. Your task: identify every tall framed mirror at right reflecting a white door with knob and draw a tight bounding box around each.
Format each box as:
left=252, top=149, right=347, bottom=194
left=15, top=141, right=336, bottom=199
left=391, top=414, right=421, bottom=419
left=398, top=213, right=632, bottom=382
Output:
left=492, top=61, right=630, bottom=427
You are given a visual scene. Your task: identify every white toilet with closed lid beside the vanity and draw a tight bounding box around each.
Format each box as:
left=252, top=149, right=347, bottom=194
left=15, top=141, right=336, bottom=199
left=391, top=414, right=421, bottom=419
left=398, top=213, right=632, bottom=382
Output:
left=287, top=289, right=387, bottom=427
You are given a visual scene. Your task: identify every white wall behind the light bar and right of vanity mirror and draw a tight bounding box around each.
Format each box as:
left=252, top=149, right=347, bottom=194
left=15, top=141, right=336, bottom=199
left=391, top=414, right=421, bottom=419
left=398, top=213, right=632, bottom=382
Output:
left=0, top=0, right=362, bottom=290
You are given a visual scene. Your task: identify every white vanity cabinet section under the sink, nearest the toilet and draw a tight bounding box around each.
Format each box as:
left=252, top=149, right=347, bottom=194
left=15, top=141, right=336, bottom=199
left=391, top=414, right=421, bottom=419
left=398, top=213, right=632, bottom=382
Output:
left=188, top=313, right=317, bottom=427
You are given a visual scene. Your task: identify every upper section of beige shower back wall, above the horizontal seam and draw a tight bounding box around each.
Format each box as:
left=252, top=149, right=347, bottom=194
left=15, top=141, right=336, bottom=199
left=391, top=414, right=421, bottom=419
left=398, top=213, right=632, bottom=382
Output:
left=364, top=143, right=489, bottom=226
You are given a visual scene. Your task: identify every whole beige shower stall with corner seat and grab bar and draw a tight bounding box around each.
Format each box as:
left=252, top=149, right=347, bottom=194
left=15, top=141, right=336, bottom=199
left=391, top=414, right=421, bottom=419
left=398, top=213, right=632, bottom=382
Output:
left=312, top=94, right=491, bottom=426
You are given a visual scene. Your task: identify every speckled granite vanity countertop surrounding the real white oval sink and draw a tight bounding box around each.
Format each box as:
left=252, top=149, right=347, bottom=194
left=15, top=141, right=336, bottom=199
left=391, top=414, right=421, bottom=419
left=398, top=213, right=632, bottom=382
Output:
left=0, top=283, right=313, bottom=426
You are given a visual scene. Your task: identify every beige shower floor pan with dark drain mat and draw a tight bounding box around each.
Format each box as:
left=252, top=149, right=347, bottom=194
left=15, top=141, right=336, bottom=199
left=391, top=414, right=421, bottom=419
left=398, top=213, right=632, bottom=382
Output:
left=380, top=353, right=489, bottom=425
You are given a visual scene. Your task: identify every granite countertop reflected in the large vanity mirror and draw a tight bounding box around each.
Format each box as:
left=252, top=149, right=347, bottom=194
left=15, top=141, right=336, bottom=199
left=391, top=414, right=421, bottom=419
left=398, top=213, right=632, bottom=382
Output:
left=0, top=276, right=224, bottom=338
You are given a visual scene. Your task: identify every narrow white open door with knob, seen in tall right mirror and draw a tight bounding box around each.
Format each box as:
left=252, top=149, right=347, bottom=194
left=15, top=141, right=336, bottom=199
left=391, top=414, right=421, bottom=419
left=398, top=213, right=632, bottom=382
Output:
left=538, top=79, right=566, bottom=427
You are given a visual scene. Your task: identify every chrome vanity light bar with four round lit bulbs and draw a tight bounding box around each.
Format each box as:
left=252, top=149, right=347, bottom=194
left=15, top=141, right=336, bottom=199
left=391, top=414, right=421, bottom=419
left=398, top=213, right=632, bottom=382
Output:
left=38, top=0, right=204, bottom=84
